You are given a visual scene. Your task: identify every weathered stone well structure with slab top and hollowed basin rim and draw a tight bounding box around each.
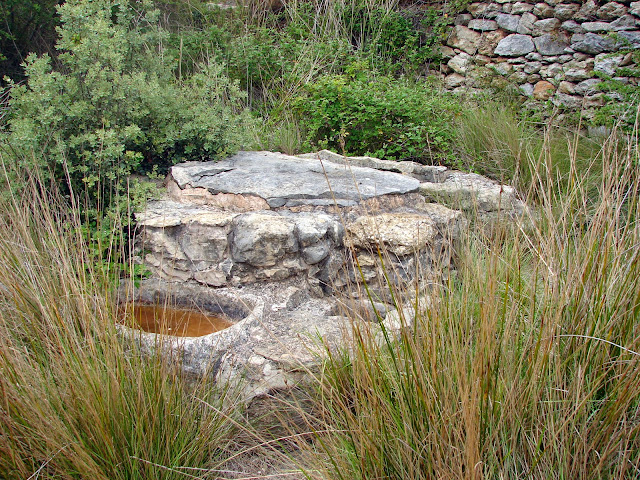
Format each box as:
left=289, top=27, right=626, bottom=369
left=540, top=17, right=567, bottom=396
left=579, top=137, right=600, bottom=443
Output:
left=130, top=151, right=526, bottom=400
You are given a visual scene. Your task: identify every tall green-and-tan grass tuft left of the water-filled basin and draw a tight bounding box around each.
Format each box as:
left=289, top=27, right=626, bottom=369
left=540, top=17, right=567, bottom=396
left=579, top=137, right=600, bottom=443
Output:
left=0, top=166, right=240, bottom=480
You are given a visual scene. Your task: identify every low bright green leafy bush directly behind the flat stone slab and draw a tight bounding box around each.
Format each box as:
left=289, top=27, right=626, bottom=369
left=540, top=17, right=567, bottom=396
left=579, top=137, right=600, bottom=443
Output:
left=295, top=72, right=460, bottom=163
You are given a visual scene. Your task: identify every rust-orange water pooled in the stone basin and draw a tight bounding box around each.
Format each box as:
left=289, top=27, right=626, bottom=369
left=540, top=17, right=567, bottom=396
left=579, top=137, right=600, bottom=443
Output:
left=120, top=304, right=233, bottom=337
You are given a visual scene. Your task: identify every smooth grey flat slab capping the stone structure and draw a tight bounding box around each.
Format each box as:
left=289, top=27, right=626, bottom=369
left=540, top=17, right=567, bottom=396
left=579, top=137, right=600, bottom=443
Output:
left=171, top=152, right=420, bottom=208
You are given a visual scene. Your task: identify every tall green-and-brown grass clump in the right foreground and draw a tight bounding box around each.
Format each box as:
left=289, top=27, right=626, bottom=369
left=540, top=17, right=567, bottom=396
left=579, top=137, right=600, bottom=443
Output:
left=318, top=124, right=640, bottom=480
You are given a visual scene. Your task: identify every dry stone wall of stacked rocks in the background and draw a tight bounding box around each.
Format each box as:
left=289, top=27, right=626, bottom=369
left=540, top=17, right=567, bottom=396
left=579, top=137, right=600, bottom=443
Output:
left=442, top=0, right=640, bottom=109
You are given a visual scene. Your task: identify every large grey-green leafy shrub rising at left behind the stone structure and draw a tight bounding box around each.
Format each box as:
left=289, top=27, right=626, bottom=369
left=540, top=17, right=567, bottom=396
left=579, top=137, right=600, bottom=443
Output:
left=9, top=0, right=255, bottom=208
